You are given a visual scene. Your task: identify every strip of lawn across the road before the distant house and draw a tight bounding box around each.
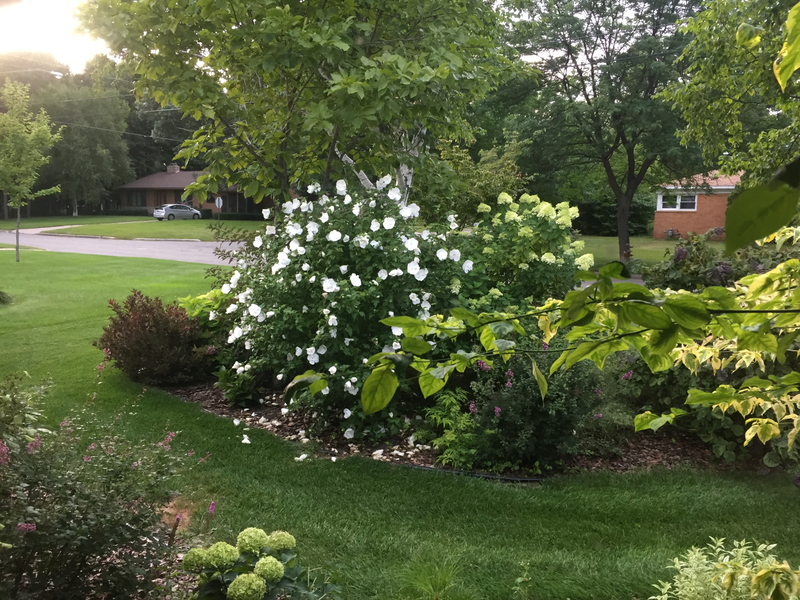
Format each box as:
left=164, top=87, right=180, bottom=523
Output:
left=55, top=218, right=264, bottom=242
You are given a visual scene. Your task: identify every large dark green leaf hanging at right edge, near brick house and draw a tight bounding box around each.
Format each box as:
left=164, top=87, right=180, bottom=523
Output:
left=725, top=182, right=800, bottom=253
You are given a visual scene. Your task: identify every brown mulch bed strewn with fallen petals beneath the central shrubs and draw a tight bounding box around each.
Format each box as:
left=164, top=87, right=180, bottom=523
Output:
left=167, top=384, right=769, bottom=477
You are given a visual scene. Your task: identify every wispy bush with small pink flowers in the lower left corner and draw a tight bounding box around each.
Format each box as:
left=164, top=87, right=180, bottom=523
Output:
left=0, top=377, right=189, bottom=600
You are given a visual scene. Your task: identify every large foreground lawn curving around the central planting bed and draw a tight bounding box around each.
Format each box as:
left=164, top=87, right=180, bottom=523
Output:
left=0, top=252, right=800, bottom=600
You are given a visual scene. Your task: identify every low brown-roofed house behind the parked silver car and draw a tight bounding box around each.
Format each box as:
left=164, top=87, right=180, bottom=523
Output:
left=119, top=164, right=270, bottom=214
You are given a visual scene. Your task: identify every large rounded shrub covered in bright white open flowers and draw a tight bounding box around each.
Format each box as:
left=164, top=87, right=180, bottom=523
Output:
left=212, top=178, right=474, bottom=414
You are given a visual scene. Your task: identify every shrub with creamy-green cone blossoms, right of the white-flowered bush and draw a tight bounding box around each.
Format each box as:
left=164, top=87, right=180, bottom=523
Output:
left=465, top=193, right=594, bottom=310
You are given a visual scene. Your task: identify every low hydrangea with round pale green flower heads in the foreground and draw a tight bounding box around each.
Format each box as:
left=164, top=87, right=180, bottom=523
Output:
left=183, top=527, right=341, bottom=600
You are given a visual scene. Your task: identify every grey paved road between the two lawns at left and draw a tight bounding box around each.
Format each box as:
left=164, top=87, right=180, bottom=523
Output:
left=0, top=229, right=227, bottom=265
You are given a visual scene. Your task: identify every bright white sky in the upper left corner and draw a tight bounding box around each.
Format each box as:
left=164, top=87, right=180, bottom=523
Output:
left=0, top=0, right=106, bottom=73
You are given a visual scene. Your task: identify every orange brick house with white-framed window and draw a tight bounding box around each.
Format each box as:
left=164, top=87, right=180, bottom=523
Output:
left=653, top=171, right=740, bottom=240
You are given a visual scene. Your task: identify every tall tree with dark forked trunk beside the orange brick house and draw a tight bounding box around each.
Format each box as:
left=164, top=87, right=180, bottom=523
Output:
left=507, top=0, right=699, bottom=260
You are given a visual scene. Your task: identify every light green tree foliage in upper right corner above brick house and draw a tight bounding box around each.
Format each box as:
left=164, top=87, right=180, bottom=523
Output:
left=665, top=0, right=800, bottom=183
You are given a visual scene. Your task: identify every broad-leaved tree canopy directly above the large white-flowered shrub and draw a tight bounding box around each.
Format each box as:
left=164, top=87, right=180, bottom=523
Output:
left=82, top=0, right=503, bottom=200
